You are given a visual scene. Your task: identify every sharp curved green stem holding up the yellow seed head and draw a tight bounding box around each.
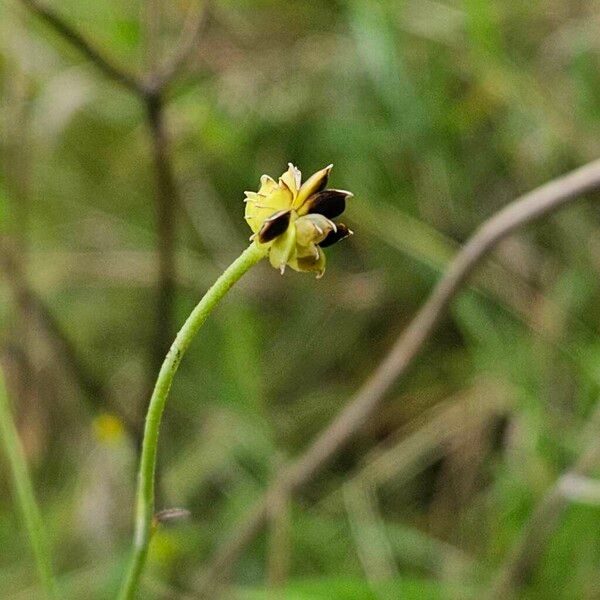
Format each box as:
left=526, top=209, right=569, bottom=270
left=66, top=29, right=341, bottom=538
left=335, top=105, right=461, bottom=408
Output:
left=119, top=244, right=265, bottom=600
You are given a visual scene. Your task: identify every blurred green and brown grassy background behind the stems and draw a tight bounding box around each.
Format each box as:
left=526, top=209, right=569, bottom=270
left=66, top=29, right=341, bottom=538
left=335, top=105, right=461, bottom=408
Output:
left=0, top=0, right=600, bottom=600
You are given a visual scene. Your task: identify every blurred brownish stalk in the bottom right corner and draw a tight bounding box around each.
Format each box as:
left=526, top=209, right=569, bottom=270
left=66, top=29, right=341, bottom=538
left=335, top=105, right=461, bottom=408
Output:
left=485, top=406, right=600, bottom=600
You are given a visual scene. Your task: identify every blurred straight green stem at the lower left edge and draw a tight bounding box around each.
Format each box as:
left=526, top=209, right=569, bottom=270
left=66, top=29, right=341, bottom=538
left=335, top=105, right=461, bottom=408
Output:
left=0, top=370, right=59, bottom=599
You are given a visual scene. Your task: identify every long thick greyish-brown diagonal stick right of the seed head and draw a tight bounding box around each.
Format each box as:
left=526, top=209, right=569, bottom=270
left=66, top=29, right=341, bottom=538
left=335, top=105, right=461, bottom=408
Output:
left=202, top=160, right=600, bottom=593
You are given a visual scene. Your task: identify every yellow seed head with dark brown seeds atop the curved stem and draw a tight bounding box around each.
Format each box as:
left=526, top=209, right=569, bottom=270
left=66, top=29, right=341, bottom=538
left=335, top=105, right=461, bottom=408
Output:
left=244, top=163, right=352, bottom=278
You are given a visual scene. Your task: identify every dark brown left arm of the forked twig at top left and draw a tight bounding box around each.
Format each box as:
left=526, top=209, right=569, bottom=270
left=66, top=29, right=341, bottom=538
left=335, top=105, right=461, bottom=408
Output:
left=20, top=0, right=147, bottom=97
